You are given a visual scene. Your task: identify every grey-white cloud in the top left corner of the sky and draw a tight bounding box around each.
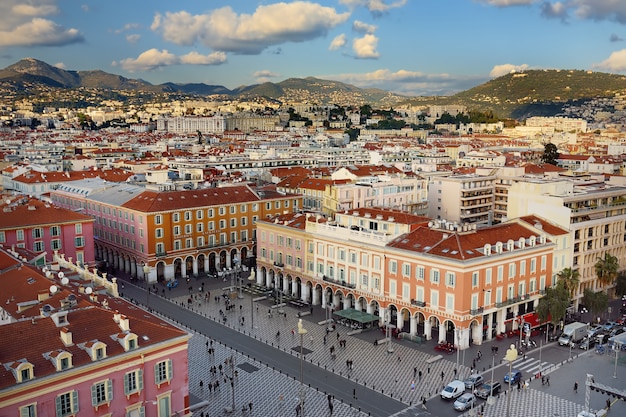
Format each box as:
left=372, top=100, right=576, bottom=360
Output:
left=0, top=0, right=84, bottom=47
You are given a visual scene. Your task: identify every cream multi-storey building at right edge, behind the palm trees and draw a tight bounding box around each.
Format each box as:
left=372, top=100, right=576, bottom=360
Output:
left=507, top=179, right=626, bottom=305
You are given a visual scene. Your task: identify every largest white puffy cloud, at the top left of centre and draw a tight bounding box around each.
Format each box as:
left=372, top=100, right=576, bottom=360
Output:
left=151, top=1, right=350, bottom=54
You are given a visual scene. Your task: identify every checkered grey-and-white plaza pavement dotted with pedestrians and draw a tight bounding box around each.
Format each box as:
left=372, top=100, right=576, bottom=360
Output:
left=118, top=272, right=615, bottom=417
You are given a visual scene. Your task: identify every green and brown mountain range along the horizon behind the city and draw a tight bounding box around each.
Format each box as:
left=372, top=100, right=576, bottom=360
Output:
left=0, top=58, right=626, bottom=118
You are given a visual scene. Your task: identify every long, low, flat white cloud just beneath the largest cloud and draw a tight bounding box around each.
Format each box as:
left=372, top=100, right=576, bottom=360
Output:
left=113, top=48, right=226, bottom=72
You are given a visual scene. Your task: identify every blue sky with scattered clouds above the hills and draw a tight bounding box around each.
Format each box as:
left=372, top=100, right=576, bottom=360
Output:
left=0, top=0, right=626, bottom=95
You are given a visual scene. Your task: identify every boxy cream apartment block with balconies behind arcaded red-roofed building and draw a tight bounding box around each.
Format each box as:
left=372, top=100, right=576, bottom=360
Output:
left=428, top=174, right=496, bottom=225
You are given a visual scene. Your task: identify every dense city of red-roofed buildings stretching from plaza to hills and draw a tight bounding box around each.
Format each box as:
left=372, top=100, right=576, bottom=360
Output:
left=0, top=97, right=626, bottom=416
